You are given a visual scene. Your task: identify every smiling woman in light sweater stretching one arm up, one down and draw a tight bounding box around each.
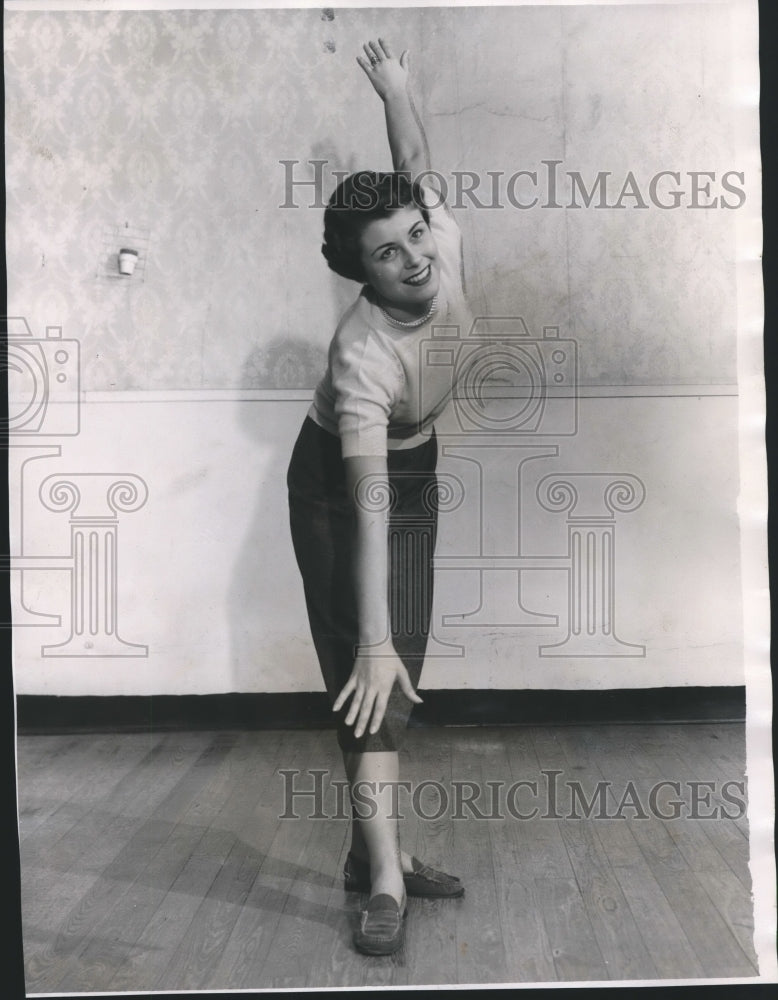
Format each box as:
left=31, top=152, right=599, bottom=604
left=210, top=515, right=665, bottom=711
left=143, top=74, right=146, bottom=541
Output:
left=288, top=39, right=468, bottom=954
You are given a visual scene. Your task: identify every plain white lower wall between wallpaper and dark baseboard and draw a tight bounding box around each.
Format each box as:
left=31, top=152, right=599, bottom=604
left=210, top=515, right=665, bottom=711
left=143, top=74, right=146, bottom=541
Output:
left=11, top=394, right=744, bottom=695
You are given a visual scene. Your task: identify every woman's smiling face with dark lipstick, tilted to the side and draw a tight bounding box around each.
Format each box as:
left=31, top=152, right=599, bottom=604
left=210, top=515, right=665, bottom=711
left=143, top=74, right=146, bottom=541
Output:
left=360, top=205, right=440, bottom=318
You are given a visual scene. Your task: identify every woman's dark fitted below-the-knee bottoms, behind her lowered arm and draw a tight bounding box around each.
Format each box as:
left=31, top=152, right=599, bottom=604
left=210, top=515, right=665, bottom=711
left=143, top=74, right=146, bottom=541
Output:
left=287, top=417, right=437, bottom=753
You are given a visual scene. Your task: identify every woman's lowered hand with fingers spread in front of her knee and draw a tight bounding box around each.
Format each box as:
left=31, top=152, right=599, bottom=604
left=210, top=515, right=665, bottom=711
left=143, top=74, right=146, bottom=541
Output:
left=332, top=645, right=422, bottom=739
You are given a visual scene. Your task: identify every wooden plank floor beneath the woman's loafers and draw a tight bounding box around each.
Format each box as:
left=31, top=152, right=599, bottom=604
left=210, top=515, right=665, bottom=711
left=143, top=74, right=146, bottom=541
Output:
left=18, top=724, right=757, bottom=993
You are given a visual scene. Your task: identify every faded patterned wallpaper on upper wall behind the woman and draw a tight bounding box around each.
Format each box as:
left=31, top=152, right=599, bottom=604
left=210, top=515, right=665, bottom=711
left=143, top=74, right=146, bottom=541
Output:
left=5, top=5, right=738, bottom=390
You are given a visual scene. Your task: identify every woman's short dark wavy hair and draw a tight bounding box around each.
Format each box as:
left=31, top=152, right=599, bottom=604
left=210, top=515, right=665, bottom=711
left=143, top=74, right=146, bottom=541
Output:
left=321, top=170, right=430, bottom=282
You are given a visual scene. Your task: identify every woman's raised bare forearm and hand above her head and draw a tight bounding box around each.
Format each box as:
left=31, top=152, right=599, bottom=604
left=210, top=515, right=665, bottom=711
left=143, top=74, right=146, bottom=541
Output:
left=357, top=38, right=430, bottom=179
